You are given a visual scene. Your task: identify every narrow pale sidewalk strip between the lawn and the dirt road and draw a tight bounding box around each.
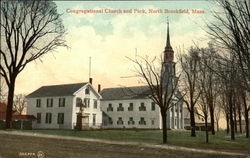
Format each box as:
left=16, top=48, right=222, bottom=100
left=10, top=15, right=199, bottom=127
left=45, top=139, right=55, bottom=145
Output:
left=0, top=130, right=250, bottom=158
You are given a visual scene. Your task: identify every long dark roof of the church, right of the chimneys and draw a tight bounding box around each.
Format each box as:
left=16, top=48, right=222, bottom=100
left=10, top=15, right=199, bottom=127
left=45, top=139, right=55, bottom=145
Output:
left=100, top=86, right=151, bottom=100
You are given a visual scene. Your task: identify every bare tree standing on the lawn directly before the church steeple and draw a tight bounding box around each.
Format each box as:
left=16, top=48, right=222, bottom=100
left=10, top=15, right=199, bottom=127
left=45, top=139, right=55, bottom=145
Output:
left=129, top=56, right=181, bottom=144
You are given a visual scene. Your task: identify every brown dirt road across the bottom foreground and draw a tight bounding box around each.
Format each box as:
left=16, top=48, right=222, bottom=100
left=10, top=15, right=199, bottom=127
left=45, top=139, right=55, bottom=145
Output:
left=0, top=133, right=245, bottom=158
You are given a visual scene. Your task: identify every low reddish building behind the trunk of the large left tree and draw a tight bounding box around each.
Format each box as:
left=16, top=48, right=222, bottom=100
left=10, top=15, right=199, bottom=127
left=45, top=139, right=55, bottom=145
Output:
left=0, top=102, right=36, bottom=129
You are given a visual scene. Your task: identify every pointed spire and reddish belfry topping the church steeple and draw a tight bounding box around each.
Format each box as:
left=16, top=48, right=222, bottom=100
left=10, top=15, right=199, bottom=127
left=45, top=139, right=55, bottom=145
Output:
left=164, top=18, right=174, bottom=62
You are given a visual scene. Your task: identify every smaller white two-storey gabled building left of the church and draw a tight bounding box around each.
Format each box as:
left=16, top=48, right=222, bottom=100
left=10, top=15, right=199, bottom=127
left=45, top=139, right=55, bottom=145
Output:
left=27, top=83, right=102, bottom=129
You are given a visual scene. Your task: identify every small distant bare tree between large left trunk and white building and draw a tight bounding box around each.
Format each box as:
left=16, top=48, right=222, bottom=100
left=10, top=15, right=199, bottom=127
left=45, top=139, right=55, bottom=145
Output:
left=13, top=94, right=27, bottom=115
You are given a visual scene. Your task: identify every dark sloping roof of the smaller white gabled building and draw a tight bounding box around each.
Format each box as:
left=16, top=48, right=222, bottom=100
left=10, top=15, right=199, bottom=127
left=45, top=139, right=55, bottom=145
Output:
left=27, top=82, right=87, bottom=98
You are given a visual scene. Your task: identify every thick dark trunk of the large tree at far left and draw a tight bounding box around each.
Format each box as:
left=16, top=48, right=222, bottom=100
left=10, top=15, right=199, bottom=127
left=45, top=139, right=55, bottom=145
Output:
left=5, top=77, right=16, bottom=129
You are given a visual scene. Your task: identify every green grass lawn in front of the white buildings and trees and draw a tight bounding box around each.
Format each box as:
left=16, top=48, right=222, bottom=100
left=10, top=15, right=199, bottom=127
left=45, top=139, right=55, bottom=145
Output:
left=21, top=130, right=250, bottom=153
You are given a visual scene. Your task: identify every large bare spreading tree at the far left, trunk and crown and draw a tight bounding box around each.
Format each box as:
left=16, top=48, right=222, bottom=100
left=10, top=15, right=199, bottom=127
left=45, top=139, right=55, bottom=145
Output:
left=0, top=0, right=66, bottom=129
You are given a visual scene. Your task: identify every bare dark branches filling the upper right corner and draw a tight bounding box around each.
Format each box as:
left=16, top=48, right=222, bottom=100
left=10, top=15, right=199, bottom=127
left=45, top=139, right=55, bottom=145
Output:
left=207, top=0, right=250, bottom=92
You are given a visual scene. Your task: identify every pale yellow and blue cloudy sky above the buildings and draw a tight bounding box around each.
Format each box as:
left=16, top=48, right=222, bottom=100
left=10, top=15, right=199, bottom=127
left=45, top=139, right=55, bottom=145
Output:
left=15, top=0, right=215, bottom=94
